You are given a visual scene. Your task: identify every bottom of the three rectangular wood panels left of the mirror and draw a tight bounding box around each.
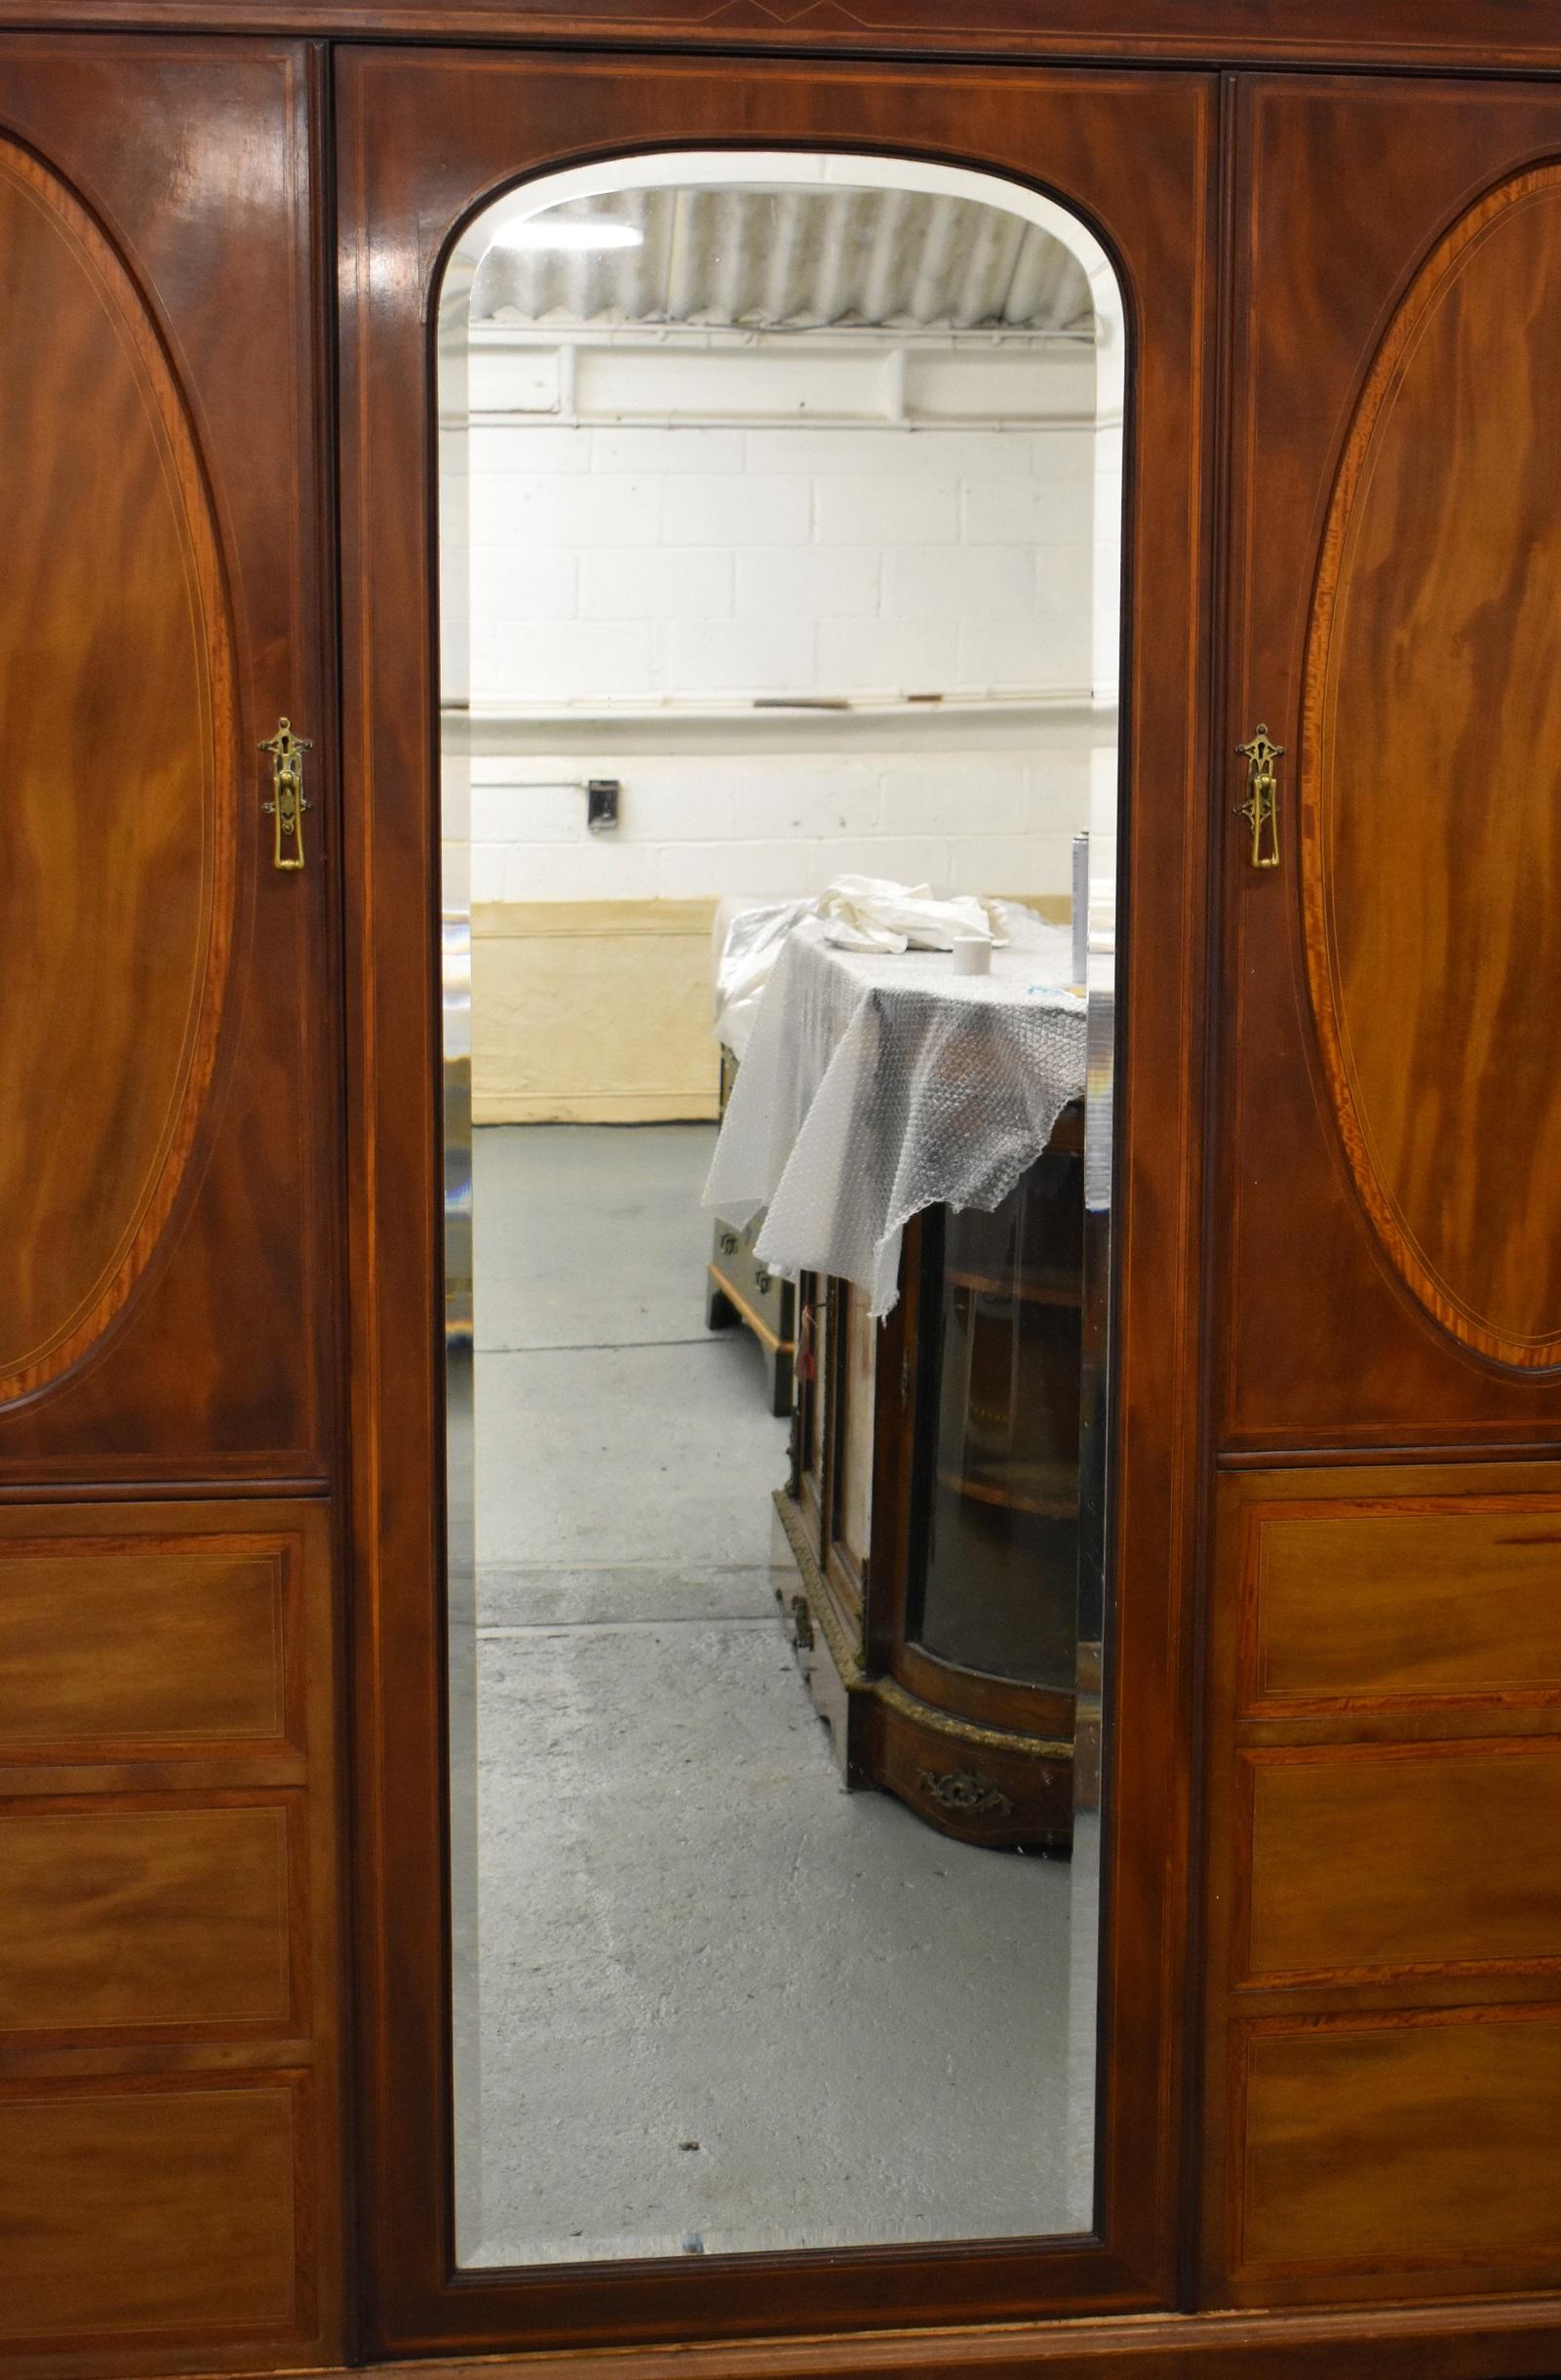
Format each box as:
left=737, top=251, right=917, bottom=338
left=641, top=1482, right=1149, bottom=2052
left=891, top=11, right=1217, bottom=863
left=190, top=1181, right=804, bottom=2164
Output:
left=0, top=2076, right=307, bottom=2342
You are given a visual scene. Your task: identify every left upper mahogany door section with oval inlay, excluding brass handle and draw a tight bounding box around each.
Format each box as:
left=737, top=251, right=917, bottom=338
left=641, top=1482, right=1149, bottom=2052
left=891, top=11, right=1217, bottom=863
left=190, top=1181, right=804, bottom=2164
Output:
left=0, top=31, right=338, bottom=1490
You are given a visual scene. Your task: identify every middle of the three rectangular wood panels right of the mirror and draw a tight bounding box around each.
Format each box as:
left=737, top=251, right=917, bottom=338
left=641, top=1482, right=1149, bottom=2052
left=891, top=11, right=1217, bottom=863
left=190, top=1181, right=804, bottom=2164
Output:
left=1237, top=1739, right=1561, bottom=1980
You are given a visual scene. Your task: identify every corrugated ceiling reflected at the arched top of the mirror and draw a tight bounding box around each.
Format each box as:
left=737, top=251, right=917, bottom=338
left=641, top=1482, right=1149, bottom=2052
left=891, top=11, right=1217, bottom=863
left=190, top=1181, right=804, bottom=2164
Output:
left=471, top=185, right=1095, bottom=338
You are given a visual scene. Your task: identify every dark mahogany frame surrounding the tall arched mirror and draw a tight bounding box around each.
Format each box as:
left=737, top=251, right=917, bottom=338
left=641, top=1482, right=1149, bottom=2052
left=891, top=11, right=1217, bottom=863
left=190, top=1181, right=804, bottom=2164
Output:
left=338, top=48, right=1216, bottom=2354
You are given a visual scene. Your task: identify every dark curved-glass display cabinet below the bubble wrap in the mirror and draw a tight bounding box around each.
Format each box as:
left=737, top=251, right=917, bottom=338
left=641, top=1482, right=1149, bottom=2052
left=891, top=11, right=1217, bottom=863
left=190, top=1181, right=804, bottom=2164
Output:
left=776, top=1102, right=1102, bottom=1852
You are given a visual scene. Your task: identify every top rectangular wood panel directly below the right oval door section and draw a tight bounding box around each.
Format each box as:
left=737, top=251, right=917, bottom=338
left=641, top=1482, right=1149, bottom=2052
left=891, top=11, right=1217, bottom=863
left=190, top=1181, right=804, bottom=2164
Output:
left=1242, top=1497, right=1561, bottom=1711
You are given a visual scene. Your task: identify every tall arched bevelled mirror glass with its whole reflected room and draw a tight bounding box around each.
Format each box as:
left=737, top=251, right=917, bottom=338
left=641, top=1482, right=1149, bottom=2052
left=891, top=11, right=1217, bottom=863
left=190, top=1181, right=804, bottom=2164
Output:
left=441, top=152, right=1123, bottom=2266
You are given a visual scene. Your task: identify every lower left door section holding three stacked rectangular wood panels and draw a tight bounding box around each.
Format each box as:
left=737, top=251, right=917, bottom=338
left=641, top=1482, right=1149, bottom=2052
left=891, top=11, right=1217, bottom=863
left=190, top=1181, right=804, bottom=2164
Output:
left=0, top=1497, right=345, bottom=2380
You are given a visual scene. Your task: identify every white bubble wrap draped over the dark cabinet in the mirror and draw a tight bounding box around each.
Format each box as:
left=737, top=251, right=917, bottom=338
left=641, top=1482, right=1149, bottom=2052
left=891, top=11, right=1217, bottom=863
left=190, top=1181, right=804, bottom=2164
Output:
left=704, top=918, right=1085, bottom=1316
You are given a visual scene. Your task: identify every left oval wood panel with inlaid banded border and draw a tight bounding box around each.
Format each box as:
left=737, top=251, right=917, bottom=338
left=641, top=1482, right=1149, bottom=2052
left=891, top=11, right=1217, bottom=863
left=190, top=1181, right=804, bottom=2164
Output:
left=0, top=142, right=233, bottom=1397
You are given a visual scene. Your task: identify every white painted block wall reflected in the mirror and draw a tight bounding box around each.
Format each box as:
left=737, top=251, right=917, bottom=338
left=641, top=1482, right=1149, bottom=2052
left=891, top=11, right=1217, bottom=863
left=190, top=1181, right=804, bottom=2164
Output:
left=452, top=421, right=1120, bottom=902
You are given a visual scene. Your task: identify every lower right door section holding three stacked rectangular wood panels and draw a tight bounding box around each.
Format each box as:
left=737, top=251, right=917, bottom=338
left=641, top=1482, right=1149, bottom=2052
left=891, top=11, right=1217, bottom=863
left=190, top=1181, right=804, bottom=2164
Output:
left=1199, top=1456, right=1561, bottom=2313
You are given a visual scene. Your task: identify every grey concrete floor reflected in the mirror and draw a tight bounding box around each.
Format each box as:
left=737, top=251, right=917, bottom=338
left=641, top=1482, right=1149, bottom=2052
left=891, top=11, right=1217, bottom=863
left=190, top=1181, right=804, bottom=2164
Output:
left=452, top=1126, right=1095, bottom=2263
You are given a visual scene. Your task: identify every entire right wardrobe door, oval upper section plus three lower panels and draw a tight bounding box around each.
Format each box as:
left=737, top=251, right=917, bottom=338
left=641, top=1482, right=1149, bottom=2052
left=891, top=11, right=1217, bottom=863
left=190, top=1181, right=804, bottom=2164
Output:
left=1204, top=81, right=1561, bottom=2304
